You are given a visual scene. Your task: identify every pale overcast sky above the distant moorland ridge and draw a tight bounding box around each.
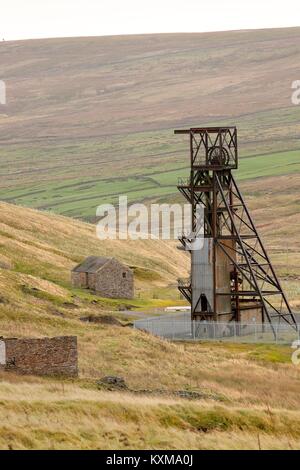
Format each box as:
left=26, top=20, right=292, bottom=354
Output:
left=0, top=0, right=300, bottom=40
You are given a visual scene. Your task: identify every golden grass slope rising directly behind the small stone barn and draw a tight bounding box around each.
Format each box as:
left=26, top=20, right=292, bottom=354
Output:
left=0, top=202, right=188, bottom=286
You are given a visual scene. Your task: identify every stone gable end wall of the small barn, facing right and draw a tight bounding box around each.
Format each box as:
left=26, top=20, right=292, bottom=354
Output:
left=95, top=259, right=134, bottom=299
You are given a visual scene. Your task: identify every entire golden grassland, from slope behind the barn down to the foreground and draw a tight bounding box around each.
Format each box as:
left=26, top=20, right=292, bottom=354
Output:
left=0, top=203, right=300, bottom=449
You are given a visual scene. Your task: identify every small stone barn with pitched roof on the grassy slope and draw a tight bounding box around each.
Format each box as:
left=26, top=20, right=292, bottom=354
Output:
left=71, top=256, right=134, bottom=299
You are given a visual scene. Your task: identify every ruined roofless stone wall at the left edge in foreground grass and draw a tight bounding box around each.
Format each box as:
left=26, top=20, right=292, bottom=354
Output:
left=0, top=336, right=78, bottom=377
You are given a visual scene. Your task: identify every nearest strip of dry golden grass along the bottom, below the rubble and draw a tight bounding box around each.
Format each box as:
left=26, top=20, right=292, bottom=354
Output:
left=0, top=378, right=300, bottom=449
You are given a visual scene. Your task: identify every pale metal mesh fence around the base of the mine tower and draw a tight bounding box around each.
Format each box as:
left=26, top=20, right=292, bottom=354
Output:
left=134, top=312, right=300, bottom=344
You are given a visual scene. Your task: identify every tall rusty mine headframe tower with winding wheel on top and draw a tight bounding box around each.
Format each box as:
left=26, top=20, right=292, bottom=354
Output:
left=175, top=127, right=297, bottom=328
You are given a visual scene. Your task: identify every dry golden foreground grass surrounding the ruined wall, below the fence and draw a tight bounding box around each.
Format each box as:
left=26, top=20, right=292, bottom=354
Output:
left=0, top=315, right=300, bottom=449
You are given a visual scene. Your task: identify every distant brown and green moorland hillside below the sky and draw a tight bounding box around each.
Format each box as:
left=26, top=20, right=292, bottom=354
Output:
left=0, top=28, right=300, bottom=220
